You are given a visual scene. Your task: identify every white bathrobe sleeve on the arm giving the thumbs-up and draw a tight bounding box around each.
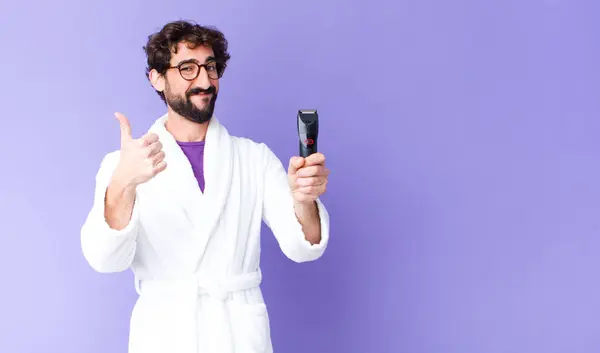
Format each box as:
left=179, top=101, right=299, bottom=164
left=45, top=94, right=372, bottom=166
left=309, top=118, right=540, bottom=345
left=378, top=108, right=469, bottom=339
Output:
left=81, top=151, right=139, bottom=273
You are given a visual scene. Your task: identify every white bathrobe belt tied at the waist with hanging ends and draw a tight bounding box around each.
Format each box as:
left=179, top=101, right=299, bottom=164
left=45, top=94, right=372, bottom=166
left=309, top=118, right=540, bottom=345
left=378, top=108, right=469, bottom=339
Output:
left=135, top=270, right=262, bottom=353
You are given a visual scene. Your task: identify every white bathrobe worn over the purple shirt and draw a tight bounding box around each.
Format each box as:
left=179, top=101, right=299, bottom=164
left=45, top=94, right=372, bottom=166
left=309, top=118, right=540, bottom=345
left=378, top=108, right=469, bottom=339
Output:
left=81, top=115, right=329, bottom=353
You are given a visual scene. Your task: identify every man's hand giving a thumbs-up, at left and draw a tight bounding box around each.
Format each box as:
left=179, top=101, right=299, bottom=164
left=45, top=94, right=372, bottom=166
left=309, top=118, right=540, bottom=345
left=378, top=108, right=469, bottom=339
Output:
left=114, top=113, right=167, bottom=188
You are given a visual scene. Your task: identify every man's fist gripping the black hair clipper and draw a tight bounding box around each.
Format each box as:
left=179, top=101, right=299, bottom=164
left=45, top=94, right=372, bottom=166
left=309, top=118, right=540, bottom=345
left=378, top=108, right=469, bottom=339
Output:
left=288, top=153, right=329, bottom=204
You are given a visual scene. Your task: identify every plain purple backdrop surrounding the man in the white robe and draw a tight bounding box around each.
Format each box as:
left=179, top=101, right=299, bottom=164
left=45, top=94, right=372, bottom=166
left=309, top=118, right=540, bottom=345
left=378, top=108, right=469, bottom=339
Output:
left=0, top=0, right=600, bottom=353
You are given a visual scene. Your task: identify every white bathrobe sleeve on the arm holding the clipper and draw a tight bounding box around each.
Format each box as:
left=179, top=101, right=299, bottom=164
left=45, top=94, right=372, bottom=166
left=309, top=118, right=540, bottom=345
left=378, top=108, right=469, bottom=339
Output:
left=261, top=144, right=329, bottom=262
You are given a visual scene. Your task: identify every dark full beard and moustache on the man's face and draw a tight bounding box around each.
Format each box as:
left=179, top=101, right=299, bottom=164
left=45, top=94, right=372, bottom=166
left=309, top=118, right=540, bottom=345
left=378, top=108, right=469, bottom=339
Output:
left=165, top=84, right=217, bottom=124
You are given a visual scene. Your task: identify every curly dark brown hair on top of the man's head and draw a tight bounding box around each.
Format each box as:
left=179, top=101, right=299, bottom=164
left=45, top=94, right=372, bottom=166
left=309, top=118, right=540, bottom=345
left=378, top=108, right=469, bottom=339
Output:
left=144, top=20, right=231, bottom=103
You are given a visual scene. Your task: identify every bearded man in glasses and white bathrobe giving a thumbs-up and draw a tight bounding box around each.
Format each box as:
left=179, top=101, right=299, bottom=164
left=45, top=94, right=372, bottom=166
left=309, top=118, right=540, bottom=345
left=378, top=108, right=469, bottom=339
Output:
left=81, top=21, right=329, bottom=353
